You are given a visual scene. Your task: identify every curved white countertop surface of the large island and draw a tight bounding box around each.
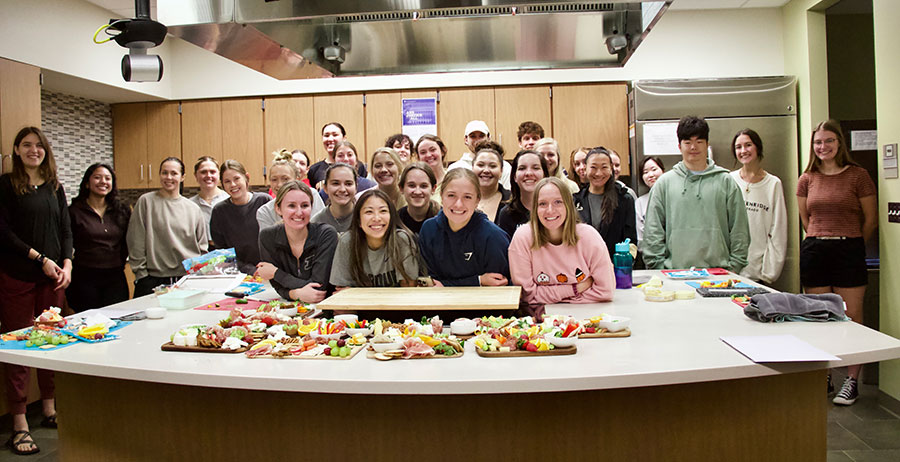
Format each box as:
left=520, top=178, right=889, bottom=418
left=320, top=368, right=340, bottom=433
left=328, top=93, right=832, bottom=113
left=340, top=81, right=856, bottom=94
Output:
left=0, top=272, right=900, bottom=394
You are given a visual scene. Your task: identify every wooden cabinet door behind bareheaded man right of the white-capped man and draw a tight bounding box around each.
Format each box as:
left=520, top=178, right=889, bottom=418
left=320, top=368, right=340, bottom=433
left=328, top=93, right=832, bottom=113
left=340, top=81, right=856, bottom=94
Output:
left=490, top=85, right=553, bottom=159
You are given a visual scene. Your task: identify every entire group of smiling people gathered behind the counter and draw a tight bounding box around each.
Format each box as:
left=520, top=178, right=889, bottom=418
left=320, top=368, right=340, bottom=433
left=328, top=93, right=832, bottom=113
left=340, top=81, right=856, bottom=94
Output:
left=0, top=117, right=876, bottom=453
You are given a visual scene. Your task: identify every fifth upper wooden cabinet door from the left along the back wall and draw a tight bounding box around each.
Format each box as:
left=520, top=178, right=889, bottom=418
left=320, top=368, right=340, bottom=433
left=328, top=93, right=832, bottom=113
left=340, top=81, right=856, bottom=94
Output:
left=263, top=96, right=314, bottom=164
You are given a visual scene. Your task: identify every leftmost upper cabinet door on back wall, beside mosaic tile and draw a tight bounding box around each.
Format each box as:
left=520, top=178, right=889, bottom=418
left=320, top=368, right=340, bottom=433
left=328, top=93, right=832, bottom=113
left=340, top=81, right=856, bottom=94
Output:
left=112, top=103, right=149, bottom=189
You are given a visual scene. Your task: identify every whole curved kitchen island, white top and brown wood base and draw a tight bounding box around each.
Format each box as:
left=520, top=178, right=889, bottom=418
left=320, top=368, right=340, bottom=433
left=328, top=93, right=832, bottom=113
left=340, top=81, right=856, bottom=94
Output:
left=0, top=272, right=900, bottom=460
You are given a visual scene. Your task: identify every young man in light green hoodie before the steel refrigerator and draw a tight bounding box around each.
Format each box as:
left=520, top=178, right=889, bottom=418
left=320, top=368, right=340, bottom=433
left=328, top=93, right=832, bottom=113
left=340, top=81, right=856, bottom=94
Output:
left=641, top=116, right=750, bottom=273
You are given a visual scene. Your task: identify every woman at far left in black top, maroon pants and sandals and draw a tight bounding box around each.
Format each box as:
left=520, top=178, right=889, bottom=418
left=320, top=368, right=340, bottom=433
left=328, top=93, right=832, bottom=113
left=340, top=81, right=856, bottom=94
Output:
left=0, top=127, right=72, bottom=455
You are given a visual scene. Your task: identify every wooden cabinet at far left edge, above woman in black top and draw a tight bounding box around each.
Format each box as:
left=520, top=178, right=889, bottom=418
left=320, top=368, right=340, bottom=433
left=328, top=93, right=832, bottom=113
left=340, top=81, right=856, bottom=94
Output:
left=0, top=58, right=41, bottom=172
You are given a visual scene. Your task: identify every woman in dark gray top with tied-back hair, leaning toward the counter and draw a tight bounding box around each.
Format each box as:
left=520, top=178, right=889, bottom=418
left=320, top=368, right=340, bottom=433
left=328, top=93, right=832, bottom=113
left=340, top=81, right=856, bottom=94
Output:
left=209, top=160, right=272, bottom=274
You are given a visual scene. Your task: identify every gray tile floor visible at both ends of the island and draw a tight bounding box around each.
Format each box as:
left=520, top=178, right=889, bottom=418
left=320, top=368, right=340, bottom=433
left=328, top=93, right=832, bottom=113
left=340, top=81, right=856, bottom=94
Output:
left=0, top=371, right=900, bottom=462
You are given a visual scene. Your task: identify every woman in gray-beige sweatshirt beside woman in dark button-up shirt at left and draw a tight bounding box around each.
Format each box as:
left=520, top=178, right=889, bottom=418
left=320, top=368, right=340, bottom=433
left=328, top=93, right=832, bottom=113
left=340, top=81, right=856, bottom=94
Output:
left=126, top=157, right=208, bottom=298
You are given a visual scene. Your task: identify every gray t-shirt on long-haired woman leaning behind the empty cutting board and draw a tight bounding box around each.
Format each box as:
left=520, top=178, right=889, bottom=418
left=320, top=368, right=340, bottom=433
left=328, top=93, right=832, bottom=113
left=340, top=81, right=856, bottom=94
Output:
left=330, top=230, right=419, bottom=287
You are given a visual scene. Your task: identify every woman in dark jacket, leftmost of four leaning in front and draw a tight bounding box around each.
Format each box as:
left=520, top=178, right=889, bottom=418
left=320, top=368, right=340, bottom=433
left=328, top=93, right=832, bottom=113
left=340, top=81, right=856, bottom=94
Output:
left=256, top=180, right=338, bottom=303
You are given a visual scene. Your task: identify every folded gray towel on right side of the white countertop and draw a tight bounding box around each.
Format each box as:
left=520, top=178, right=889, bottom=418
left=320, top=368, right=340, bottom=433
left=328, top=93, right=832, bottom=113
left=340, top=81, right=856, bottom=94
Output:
left=744, top=293, right=850, bottom=322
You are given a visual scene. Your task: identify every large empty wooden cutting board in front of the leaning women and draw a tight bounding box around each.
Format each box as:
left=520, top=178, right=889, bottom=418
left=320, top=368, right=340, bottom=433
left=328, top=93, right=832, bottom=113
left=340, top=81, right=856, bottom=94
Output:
left=317, top=286, right=522, bottom=311
